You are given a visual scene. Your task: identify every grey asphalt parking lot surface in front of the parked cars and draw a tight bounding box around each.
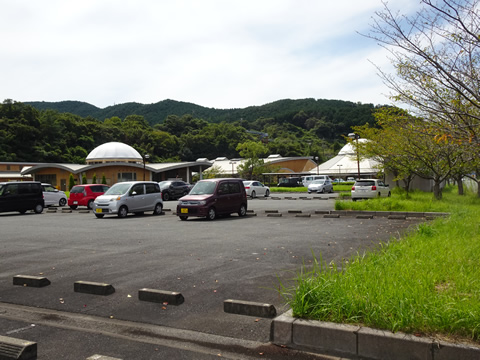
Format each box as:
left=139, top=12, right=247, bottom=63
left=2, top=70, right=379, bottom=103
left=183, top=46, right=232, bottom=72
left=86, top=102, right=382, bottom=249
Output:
left=0, top=194, right=428, bottom=359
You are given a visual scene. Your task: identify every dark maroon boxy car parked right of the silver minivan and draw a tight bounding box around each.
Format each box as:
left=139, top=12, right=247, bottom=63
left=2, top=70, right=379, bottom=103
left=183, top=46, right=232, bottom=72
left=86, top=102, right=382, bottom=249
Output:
left=177, top=179, right=247, bottom=220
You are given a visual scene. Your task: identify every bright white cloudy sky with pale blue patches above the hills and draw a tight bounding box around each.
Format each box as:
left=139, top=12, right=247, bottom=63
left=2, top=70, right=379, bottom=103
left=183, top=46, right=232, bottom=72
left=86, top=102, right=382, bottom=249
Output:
left=0, top=0, right=419, bottom=109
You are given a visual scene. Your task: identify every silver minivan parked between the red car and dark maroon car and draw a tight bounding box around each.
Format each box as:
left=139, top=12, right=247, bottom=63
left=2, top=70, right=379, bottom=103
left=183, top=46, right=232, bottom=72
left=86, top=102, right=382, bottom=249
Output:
left=93, top=181, right=163, bottom=218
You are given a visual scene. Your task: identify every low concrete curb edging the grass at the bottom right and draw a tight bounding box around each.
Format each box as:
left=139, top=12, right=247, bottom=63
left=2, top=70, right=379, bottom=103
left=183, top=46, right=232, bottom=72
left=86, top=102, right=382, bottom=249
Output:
left=270, top=310, right=480, bottom=360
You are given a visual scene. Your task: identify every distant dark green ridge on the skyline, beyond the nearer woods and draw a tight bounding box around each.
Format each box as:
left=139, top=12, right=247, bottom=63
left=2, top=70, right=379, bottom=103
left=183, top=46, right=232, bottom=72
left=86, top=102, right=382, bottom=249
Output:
left=25, top=99, right=380, bottom=132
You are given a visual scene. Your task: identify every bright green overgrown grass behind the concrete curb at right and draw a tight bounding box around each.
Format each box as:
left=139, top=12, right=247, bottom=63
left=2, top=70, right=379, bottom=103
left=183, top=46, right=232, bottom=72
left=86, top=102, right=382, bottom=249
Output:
left=281, top=189, right=480, bottom=344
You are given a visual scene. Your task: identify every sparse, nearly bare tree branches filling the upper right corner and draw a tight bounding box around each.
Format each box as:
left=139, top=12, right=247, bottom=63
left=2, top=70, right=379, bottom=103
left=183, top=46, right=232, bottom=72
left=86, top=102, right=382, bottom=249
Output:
left=366, top=0, right=480, bottom=145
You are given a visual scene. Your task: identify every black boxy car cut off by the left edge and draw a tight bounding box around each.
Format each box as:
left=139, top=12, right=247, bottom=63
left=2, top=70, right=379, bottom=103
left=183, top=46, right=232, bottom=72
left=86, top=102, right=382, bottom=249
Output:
left=0, top=181, right=45, bottom=214
